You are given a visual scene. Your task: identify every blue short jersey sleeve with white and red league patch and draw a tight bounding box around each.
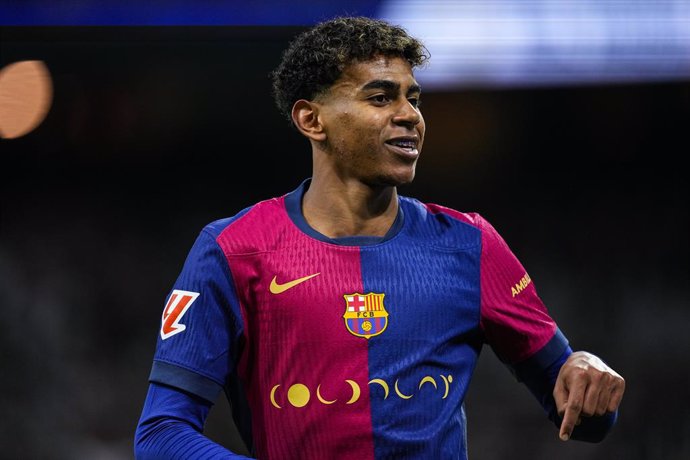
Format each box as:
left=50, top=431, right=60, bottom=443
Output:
left=149, top=229, right=242, bottom=402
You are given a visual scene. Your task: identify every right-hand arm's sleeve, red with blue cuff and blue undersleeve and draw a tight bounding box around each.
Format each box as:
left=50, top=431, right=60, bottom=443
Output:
left=475, top=216, right=618, bottom=442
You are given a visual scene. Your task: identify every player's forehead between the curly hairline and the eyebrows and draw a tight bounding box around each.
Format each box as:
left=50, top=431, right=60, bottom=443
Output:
left=332, top=56, right=417, bottom=90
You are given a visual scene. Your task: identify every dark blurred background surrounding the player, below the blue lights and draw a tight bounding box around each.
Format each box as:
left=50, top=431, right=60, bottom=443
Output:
left=0, top=27, right=690, bottom=460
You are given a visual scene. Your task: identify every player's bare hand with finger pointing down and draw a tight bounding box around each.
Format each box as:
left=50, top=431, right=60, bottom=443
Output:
left=553, top=351, right=625, bottom=441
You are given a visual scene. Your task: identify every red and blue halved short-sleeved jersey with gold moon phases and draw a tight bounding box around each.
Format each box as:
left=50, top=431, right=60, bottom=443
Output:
left=151, top=181, right=569, bottom=460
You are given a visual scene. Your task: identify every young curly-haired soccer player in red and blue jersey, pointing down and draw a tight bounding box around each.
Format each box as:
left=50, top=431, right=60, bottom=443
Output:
left=135, top=17, right=624, bottom=460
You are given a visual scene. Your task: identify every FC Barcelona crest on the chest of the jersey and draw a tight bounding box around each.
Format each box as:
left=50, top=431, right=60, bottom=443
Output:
left=343, top=292, right=388, bottom=339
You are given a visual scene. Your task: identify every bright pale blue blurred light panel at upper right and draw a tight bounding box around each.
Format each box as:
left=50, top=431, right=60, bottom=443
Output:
left=378, top=0, right=690, bottom=90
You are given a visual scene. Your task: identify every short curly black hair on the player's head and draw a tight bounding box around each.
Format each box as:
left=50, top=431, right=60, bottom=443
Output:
left=271, top=17, right=430, bottom=122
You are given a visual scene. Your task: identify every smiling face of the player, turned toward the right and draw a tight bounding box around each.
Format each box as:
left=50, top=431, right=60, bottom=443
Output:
left=315, top=57, right=425, bottom=186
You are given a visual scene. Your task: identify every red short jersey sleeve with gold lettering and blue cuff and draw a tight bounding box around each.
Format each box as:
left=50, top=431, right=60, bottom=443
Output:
left=476, top=217, right=568, bottom=365
